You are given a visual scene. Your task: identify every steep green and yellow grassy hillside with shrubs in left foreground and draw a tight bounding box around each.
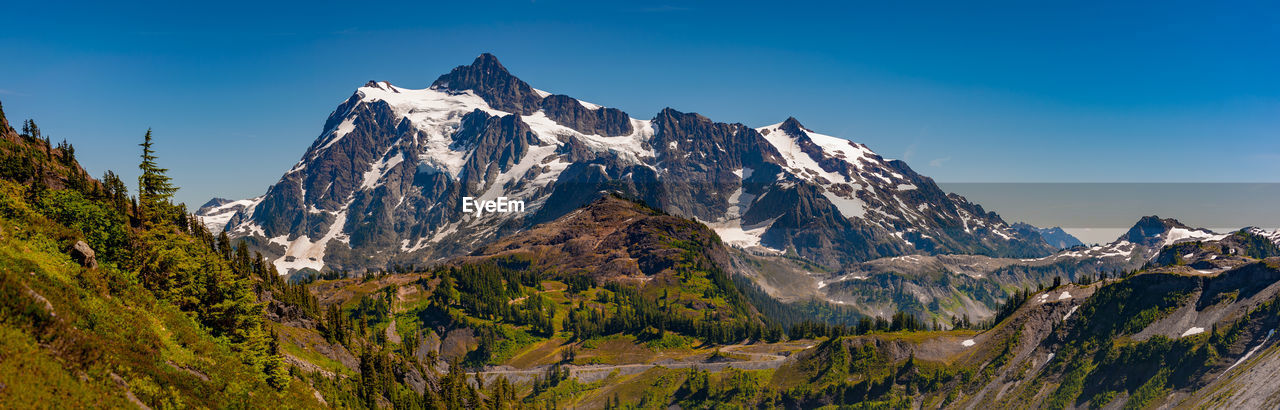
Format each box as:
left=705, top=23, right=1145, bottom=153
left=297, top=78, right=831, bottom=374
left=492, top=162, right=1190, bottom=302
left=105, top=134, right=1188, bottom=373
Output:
left=0, top=108, right=319, bottom=407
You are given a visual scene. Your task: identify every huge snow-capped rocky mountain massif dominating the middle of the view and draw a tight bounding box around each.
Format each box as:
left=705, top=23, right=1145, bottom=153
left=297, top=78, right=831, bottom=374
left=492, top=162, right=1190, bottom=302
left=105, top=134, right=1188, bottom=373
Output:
left=200, top=54, right=1052, bottom=272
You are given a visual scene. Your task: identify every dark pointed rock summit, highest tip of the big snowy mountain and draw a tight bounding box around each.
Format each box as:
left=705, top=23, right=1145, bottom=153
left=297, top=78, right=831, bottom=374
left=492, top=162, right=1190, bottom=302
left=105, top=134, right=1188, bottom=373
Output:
left=431, top=53, right=541, bottom=115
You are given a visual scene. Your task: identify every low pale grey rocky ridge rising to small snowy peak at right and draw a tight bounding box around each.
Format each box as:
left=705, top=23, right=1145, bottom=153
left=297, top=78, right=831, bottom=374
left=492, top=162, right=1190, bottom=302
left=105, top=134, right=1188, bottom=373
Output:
left=788, top=217, right=1239, bottom=323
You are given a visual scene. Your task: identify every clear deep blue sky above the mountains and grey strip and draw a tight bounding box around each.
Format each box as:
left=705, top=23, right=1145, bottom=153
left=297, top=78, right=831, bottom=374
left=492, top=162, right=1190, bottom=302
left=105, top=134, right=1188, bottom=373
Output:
left=0, top=0, right=1280, bottom=210
